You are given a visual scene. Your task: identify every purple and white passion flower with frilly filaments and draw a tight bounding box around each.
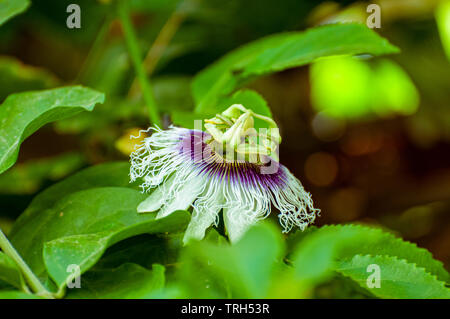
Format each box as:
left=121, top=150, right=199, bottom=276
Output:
left=130, top=104, right=320, bottom=243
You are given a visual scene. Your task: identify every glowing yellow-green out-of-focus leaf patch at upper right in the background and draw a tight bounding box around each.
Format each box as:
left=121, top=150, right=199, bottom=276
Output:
left=311, top=57, right=419, bottom=119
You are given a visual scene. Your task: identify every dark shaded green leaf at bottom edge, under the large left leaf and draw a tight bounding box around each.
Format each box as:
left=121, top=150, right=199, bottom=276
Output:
left=67, top=263, right=165, bottom=299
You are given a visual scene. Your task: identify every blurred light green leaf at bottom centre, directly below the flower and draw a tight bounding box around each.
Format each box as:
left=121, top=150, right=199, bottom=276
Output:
left=180, top=223, right=283, bottom=298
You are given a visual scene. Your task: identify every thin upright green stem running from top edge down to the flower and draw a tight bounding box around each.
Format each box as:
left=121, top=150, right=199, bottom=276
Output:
left=117, top=0, right=161, bottom=127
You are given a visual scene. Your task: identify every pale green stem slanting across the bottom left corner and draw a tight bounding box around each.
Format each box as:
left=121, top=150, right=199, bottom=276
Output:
left=0, top=229, right=52, bottom=298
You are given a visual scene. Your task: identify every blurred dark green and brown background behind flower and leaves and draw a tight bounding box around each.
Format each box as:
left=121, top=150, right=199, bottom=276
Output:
left=0, top=0, right=450, bottom=269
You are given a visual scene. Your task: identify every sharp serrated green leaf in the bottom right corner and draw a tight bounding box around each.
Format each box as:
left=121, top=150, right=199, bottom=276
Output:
left=336, top=255, right=450, bottom=299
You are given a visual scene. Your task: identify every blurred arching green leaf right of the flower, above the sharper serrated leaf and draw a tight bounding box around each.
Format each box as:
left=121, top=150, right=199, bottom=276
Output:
left=292, top=225, right=449, bottom=281
